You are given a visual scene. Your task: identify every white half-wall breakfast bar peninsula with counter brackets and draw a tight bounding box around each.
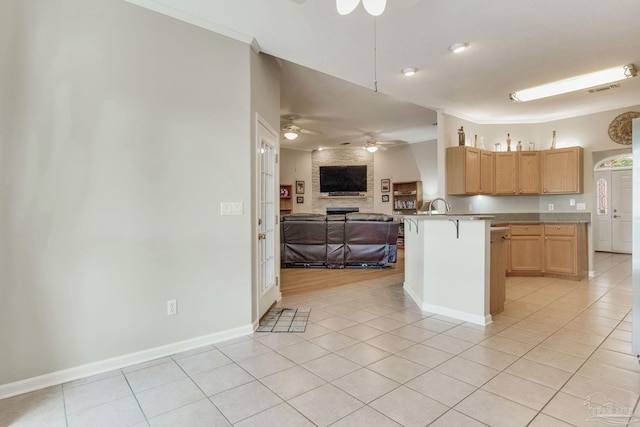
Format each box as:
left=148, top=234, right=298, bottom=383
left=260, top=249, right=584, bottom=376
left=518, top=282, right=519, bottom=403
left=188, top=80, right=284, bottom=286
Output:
left=397, top=214, right=493, bottom=325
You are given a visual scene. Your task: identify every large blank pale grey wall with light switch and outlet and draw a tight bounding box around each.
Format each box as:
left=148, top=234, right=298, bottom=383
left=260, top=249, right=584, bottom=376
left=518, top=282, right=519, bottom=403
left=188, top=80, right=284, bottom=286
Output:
left=0, top=0, right=277, bottom=385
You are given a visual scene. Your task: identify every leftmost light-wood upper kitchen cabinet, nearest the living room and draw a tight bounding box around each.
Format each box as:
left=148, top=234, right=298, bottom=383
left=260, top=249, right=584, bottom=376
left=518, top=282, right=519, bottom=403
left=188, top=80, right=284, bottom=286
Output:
left=447, top=146, right=480, bottom=194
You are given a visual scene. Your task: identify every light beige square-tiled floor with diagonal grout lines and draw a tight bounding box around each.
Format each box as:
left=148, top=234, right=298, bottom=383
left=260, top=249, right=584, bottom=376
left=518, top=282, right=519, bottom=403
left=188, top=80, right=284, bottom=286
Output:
left=0, top=253, right=640, bottom=427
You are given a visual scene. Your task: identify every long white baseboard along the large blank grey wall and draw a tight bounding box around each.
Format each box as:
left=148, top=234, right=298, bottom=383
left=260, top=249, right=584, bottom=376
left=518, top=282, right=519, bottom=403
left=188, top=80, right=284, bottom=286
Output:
left=0, top=324, right=257, bottom=399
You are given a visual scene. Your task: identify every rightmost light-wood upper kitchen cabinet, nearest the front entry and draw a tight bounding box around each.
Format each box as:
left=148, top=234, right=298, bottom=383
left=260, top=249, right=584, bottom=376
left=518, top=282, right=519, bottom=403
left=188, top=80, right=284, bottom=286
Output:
left=541, top=147, right=584, bottom=194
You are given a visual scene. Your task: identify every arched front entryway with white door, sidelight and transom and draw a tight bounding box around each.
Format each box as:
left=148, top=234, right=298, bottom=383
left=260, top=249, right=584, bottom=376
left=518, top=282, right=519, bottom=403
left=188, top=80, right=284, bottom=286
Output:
left=593, top=154, right=633, bottom=254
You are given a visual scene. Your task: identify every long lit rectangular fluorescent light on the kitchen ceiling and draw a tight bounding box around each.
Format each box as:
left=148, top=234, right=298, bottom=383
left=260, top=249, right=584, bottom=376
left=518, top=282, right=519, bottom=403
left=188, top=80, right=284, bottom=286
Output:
left=509, top=64, right=638, bottom=102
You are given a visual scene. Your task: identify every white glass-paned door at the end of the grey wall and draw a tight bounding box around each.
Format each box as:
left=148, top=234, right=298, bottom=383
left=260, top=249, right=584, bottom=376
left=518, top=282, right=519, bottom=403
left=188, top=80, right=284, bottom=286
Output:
left=256, top=119, right=280, bottom=318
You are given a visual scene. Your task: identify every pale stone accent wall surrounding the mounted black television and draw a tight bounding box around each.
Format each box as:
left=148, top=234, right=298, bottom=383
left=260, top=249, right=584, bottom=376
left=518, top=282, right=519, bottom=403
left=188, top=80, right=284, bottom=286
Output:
left=311, top=148, right=374, bottom=214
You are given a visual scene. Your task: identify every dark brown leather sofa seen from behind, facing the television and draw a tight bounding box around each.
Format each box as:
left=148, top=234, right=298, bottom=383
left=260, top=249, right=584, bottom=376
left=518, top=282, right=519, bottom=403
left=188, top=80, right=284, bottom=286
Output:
left=280, top=213, right=400, bottom=268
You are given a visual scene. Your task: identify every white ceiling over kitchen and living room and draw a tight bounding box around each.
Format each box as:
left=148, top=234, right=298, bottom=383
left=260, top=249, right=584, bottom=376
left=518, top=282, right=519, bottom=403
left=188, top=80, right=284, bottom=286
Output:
left=128, top=0, right=640, bottom=150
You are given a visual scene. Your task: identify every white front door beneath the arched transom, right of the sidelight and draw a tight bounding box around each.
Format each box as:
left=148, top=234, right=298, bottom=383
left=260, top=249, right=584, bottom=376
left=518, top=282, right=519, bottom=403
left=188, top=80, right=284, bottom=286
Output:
left=611, top=169, right=633, bottom=253
